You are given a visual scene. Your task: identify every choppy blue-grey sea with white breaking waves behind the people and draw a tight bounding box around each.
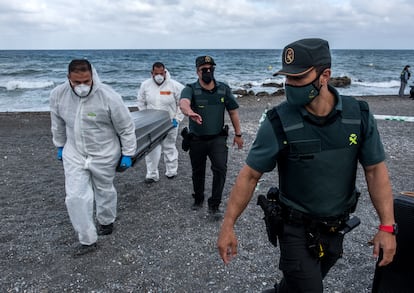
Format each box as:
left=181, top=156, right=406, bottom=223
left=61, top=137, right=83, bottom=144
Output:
left=0, top=49, right=414, bottom=112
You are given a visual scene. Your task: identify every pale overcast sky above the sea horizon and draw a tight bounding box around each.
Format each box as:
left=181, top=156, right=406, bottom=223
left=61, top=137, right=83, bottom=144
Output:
left=0, top=0, right=414, bottom=49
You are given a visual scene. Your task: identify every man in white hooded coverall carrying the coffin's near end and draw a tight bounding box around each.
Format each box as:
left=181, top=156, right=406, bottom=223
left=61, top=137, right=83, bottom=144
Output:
left=50, top=59, right=137, bottom=256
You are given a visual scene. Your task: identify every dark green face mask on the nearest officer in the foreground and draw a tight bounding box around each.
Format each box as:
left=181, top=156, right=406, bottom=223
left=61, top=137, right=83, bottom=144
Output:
left=285, top=76, right=319, bottom=106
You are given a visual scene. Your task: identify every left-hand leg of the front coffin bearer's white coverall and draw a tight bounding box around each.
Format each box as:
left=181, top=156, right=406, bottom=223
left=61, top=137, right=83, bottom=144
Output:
left=63, top=156, right=98, bottom=245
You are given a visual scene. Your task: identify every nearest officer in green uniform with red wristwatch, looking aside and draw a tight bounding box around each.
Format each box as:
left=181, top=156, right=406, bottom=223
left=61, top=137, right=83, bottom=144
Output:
left=217, top=39, right=396, bottom=293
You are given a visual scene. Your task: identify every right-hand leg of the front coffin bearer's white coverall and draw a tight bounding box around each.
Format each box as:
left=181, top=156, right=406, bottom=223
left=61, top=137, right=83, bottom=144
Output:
left=89, top=158, right=118, bottom=225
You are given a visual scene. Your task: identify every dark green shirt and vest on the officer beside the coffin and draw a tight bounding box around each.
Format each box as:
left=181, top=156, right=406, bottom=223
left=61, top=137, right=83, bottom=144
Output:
left=180, top=80, right=239, bottom=136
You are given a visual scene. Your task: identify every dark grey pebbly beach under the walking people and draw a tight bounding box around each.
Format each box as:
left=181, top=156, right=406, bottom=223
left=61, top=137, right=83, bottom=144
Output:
left=0, top=96, right=414, bottom=293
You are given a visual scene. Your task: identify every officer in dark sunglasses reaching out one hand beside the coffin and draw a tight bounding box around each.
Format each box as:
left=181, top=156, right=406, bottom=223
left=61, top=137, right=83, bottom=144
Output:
left=180, top=56, right=243, bottom=214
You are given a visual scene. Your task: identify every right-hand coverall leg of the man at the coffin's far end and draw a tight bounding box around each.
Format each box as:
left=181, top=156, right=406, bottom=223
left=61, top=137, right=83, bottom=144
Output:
left=162, top=127, right=178, bottom=177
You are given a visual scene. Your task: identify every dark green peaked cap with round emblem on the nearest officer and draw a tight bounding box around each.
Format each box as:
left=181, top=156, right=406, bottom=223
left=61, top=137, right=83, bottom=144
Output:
left=273, top=39, right=331, bottom=76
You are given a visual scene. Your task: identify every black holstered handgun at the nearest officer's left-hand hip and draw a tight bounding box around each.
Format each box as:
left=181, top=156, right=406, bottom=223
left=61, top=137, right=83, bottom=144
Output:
left=257, top=187, right=283, bottom=247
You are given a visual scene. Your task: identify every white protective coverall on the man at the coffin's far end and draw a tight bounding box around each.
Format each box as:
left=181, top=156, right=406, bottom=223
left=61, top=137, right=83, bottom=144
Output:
left=138, top=69, right=184, bottom=181
